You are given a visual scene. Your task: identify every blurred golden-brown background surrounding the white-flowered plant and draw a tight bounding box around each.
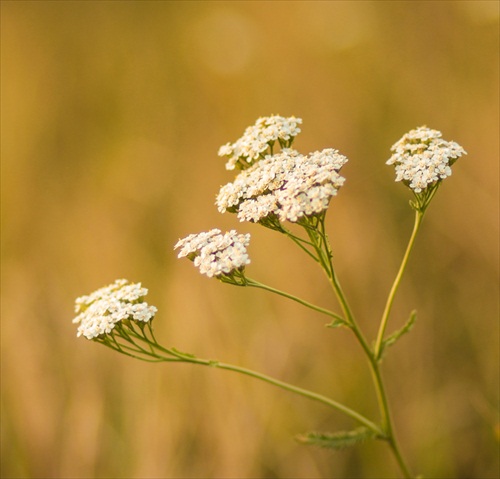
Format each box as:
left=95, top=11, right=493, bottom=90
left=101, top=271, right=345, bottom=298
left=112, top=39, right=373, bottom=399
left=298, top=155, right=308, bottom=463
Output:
left=1, top=1, right=499, bottom=479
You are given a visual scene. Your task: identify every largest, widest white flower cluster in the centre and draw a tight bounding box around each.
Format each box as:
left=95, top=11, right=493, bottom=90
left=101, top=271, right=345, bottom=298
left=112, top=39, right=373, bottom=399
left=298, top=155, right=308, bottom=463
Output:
left=216, top=148, right=347, bottom=222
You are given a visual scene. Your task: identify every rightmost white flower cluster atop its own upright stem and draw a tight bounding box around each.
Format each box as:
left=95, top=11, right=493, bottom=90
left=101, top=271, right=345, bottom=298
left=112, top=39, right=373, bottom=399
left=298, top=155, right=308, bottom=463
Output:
left=387, top=126, right=467, bottom=193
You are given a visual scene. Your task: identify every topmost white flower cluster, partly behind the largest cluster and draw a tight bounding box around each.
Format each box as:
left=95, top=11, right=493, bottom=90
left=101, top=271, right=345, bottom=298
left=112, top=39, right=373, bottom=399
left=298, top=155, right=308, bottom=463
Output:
left=219, top=115, right=302, bottom=170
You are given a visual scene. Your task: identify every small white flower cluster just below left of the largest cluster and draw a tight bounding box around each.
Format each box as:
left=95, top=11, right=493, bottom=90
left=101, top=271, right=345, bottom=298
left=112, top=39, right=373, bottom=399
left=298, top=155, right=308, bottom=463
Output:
left=174, top=229, right=250, bottom=278
